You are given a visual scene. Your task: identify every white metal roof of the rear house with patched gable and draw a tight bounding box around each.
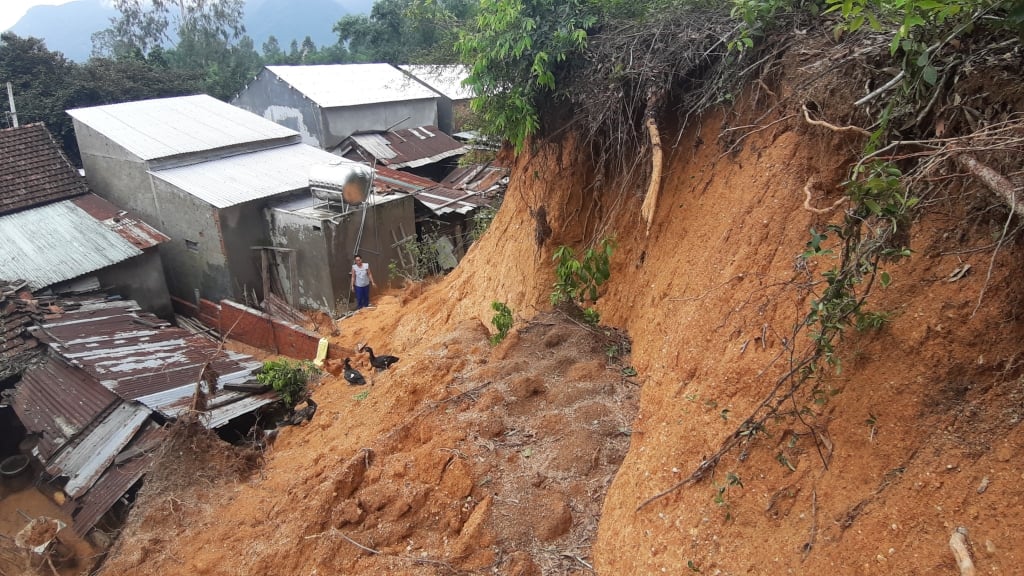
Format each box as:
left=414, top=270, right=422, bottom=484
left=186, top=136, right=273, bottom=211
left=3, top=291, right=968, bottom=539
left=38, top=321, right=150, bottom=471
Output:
left=266, top=64, right=437, bottom=108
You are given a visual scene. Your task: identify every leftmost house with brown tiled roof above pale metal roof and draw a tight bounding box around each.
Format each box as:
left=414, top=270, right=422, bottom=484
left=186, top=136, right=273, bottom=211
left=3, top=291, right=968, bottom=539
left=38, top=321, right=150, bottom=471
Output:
left=0, top=124, right=173, bottom=318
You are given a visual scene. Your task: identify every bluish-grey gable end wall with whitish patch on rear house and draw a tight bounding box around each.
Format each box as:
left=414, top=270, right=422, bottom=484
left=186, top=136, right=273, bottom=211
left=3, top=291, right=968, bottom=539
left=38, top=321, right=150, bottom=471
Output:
left=231, top=69, right=324, bottom=149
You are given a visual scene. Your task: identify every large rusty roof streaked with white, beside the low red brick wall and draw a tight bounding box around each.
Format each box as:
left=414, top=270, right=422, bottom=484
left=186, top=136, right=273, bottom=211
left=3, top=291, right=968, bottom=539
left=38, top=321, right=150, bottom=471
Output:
left=37, top=300, right=260, bottom=417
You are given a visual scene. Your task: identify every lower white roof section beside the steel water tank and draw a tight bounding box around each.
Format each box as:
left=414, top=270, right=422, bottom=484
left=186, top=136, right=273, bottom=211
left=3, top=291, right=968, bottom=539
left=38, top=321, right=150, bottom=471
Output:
left=150, top=143, right=340, bottom=208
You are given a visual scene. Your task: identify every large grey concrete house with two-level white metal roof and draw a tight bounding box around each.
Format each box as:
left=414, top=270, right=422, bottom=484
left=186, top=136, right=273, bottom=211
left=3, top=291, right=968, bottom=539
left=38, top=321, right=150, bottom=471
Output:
left=69, top=95, right=413, bottom=312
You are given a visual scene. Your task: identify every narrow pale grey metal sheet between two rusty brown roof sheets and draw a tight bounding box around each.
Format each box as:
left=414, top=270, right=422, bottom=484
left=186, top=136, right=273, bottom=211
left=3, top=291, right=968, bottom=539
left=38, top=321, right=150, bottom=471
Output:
left=46, top=402, right=151, bottom=498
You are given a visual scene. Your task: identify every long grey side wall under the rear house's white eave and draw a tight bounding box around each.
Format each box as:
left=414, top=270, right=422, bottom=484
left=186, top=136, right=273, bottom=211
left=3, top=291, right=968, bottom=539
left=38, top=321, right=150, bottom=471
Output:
left=321, top=98, right=437, bottom=152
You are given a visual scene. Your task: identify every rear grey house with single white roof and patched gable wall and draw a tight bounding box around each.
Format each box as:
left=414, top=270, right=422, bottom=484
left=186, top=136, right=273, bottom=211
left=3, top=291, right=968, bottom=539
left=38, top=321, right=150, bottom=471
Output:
left=231, top=64, right=439, bottom=152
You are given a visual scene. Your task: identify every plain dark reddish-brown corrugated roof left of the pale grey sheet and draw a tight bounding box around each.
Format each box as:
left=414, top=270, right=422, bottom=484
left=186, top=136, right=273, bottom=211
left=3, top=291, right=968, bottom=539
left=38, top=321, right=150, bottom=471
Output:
left=13, top=358, right=118, bottom=460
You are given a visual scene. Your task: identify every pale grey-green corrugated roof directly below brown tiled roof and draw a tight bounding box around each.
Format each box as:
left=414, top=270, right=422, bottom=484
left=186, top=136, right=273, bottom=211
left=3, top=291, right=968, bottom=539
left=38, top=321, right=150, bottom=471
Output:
left=0, top=200, right=142, bottom=290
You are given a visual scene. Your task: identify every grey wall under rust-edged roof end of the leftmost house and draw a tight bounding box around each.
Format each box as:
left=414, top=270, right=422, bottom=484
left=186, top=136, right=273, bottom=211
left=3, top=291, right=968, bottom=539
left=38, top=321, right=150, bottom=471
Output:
left=96, top=246, right=174, bottom=321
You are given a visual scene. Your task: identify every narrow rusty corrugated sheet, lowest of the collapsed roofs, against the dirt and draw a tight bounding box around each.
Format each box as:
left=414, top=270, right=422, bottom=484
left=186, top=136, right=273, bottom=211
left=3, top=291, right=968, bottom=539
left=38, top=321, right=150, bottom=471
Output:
left=61, top=422, right=167, bottom=536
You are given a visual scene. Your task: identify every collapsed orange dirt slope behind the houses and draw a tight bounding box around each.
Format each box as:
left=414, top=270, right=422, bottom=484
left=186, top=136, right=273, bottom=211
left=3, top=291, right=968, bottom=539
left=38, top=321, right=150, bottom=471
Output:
left=92, top=32, right=1024, bottom=575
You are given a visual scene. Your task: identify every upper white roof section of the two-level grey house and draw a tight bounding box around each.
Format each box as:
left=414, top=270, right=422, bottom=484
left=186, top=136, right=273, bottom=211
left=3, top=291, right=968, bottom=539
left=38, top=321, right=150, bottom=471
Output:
left=68, top=94, right=298, bottom=160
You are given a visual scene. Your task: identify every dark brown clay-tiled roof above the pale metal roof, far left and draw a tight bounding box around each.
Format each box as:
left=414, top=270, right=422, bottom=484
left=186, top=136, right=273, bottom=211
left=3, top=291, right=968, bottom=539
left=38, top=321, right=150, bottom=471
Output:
left=0, top=124, right=88, bottom=214
